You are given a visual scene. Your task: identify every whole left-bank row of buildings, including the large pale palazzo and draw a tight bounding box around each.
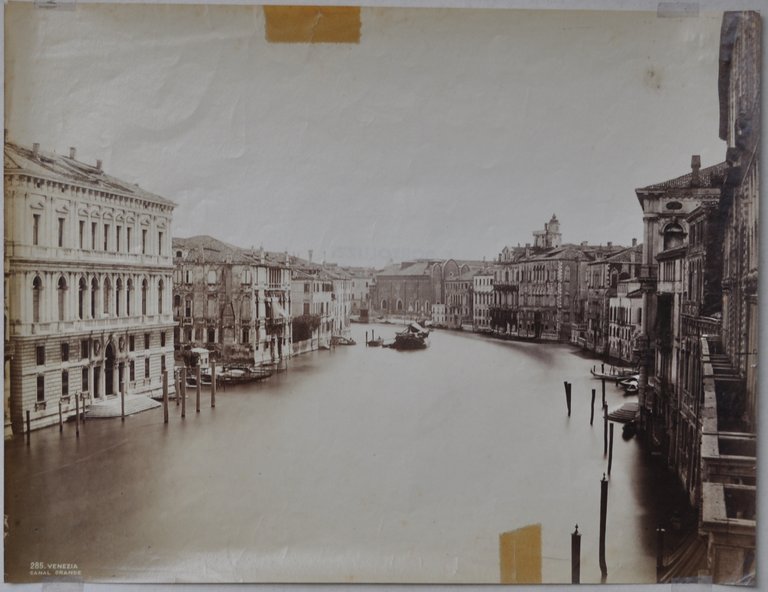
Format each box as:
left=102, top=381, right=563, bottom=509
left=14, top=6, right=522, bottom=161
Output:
left=4, top=140, right=354, bottom=435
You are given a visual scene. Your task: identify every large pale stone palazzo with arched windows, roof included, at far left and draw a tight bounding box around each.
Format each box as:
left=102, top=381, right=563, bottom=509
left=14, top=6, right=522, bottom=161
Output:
left=4, top=141, right=175, bottom=433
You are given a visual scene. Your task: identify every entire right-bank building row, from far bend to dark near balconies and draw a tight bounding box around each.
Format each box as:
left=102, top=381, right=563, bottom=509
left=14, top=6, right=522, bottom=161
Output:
left=370, top=12, right=761, bottom=582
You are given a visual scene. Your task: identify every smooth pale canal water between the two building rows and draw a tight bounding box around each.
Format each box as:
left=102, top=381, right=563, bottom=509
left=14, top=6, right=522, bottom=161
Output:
left=5, top=325, right=684, bottom=583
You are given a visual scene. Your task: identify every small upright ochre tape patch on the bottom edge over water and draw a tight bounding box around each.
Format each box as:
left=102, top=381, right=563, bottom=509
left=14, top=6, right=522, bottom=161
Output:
left=499, top=524, right=541, bottom=584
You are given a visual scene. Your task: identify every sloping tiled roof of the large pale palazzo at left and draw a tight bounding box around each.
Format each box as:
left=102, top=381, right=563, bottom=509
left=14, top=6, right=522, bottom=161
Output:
left=4, top=142, right=176, bottom=206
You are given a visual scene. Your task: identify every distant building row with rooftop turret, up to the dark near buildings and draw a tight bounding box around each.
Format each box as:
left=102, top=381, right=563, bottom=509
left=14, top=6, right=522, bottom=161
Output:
left=370, top=215, right=642, bottom=363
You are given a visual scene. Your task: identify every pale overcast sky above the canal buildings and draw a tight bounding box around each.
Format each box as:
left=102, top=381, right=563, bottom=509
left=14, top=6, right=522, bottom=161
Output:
left=6, top=4, right=725, bottom=265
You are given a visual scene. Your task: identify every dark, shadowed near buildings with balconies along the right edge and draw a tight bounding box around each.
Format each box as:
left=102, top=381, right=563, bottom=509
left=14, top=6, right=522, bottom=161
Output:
left=635, top=12, right=761, bottom=583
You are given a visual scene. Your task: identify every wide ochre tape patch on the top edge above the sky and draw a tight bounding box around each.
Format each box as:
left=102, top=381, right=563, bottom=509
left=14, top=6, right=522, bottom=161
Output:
left=264, top=6, right=360, bottom=43
